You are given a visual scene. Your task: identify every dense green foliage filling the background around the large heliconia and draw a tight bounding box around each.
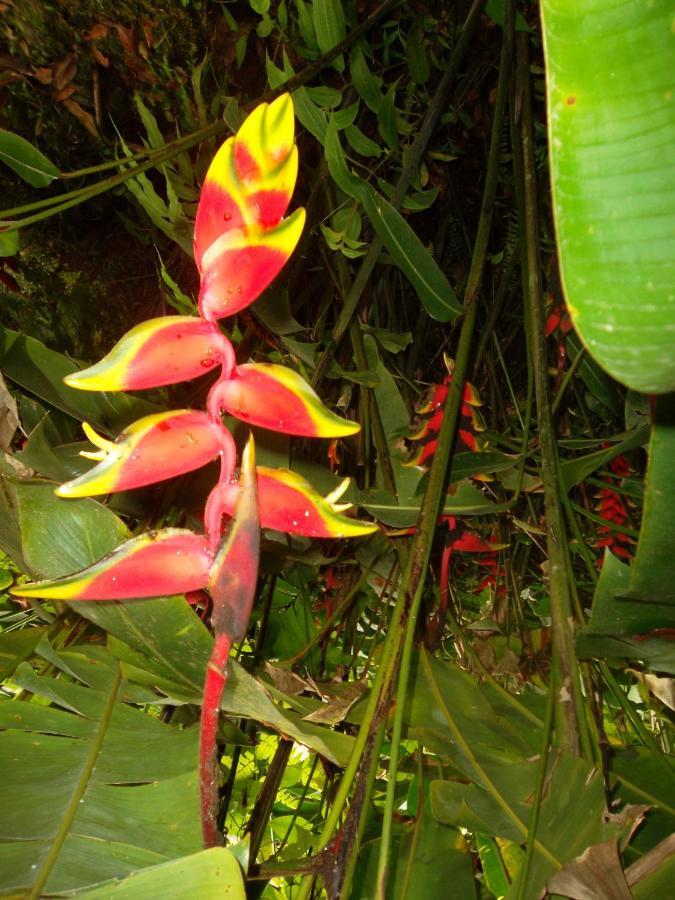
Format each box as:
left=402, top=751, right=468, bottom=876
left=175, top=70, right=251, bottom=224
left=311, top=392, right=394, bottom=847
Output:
left=0, top=0, right=675, bottom=900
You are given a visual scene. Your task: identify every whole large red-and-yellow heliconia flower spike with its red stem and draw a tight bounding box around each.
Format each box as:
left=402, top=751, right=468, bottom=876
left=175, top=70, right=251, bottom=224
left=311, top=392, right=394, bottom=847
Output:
left=12, top=94, right=377, bottom=847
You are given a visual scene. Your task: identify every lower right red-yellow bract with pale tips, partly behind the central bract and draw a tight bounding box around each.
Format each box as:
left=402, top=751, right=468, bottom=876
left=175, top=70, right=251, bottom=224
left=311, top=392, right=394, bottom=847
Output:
left=209, top=466, right=377, bottom=538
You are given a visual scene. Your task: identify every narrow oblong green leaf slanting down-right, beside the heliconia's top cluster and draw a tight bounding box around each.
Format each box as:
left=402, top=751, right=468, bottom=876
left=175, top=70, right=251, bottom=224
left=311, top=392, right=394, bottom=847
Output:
left=360, top=185, right=462, bottom=322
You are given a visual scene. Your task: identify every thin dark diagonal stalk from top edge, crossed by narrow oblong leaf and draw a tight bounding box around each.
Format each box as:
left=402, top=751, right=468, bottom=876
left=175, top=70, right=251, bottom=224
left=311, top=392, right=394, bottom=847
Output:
left=312, top=0, right=485, bottom=388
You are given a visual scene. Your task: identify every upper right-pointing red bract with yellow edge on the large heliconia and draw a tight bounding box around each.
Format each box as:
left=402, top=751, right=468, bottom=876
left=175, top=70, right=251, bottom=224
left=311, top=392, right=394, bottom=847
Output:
left=208, top=363, right=360, bottom=437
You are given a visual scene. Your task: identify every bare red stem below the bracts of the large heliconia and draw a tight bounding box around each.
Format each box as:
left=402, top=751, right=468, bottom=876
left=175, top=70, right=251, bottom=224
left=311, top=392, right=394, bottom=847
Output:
left=199, top=634, right=232, bottom=848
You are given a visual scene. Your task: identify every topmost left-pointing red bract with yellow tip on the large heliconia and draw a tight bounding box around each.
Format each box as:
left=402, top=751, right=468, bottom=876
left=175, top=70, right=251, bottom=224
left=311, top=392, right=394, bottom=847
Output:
left=64, top=316, right=234, bottom=391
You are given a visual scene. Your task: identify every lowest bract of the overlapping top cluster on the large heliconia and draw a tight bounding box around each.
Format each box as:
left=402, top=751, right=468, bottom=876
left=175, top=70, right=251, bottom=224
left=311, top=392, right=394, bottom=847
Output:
left=199, top=209, right=305, bottom=321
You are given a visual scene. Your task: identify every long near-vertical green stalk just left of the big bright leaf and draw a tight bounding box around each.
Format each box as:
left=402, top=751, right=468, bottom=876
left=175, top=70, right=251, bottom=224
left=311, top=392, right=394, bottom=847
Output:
left=514, top=34, right=593, bottom=759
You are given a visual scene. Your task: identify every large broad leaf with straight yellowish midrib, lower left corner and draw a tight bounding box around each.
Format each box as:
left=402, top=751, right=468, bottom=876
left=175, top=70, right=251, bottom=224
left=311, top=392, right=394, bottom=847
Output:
left=0, top=648, right=201, bottom=894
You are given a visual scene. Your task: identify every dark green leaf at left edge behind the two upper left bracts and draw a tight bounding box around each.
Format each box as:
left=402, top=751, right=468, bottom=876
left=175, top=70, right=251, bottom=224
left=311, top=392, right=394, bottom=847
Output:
left=0, top=326, right=163, bottom=434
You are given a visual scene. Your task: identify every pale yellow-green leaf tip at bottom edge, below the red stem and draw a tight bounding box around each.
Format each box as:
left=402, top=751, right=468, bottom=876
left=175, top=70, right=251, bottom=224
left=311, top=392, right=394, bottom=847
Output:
left=77, top=847, right=246, bottom=900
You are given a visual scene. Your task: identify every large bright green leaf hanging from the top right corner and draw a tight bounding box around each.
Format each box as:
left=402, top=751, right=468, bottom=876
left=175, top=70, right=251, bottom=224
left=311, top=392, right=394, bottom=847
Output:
left=542, top=0, right=675, bottom=393
